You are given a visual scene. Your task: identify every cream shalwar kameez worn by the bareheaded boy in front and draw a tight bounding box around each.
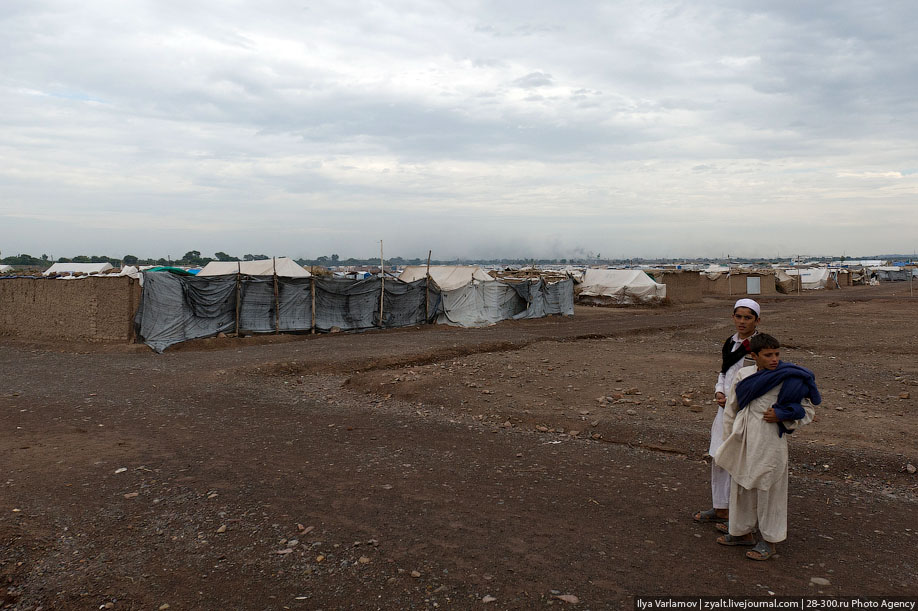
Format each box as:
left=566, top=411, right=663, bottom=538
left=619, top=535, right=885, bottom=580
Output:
left=714, top=366, right=815, bottom=543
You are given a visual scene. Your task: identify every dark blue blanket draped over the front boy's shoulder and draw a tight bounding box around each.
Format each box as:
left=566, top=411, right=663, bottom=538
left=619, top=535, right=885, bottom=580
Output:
left=736, top=361, right=822, bottom=437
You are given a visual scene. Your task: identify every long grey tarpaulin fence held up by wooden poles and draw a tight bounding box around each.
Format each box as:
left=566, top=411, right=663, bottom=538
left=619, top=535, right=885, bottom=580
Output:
left=134, top=272, right=574, bottom=352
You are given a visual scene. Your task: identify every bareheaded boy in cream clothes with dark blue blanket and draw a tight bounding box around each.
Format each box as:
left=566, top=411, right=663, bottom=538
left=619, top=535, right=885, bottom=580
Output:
left=714, top=333, right=822, bottom=560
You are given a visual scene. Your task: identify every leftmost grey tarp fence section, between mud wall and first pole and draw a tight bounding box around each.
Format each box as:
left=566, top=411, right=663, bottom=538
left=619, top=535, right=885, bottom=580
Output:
left=135, top=272, right=236, bottom=352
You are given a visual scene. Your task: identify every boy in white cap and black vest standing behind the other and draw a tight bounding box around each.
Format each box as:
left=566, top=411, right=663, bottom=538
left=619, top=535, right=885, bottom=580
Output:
left=692, top=299, right=762, bottom=522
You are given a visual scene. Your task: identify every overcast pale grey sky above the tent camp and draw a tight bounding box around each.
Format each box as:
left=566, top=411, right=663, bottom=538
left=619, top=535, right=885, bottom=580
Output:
left=0, top=0, right=918, bottom=258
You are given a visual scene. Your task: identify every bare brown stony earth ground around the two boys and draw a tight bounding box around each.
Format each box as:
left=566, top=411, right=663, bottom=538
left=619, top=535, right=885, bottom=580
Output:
left=0, top=284, right=918, bottom=609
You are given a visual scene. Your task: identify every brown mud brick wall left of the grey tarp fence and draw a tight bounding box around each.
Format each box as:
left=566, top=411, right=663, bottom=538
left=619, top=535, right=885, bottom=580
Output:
left=0, top=277, right=140, bottom=342
